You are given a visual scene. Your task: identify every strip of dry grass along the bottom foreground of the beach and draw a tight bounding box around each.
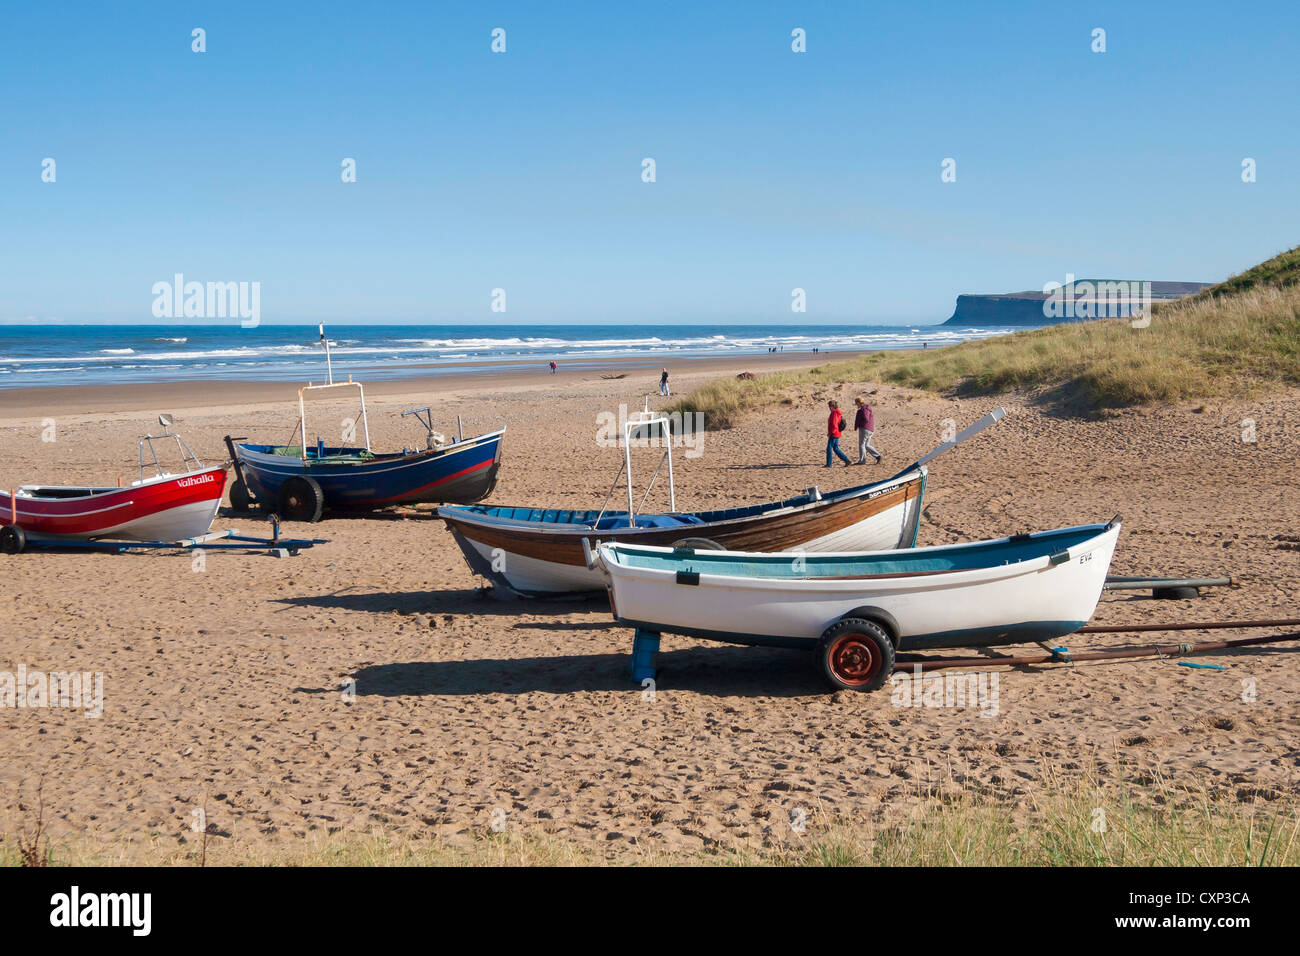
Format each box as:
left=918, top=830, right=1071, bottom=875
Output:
left=0, top=773, right=1300, bottom=866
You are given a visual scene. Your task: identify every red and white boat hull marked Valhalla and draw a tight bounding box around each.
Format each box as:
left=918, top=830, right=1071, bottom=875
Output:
left=0, top=467, right=226, bottom=541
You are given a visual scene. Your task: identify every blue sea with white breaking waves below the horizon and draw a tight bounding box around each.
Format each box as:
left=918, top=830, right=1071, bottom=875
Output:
left=0, top=323, right=1014, bottom=389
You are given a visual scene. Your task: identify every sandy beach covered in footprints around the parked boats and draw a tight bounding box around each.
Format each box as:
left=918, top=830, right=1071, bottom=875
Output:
left=0, top=355, right=1300, bottom=862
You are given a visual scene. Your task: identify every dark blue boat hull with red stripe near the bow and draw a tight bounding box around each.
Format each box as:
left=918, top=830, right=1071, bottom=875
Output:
left=234, top=429, right=504, bottom=511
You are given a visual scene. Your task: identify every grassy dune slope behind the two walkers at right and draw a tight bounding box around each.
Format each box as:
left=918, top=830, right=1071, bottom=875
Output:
left=672, top=247, right=1300, bottom=428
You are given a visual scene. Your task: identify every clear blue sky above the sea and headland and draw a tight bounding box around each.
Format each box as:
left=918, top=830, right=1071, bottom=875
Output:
left=0, top=1, right=1300, bottom=324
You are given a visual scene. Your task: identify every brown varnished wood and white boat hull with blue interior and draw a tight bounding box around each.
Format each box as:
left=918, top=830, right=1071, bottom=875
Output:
left=438, top=467, right=926, bottom=597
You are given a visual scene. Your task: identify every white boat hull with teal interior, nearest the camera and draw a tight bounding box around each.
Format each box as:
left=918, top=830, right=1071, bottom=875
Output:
left=595, top=524, right=1119, bottom=650
